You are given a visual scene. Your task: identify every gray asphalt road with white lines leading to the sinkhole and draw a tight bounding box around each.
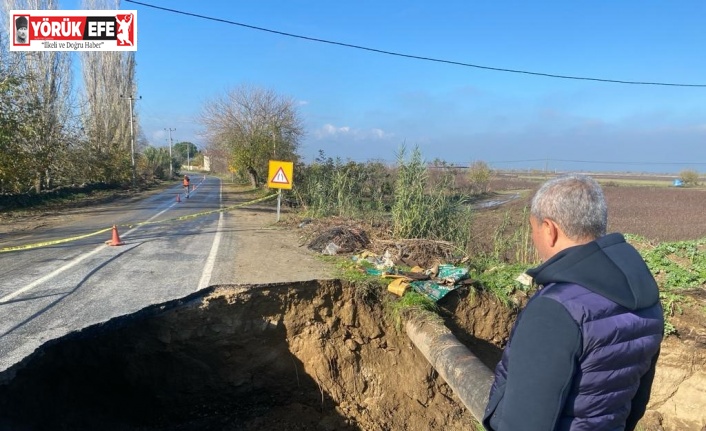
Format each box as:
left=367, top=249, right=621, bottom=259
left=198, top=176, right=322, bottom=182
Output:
left=0, top=175, right=235, bottom=372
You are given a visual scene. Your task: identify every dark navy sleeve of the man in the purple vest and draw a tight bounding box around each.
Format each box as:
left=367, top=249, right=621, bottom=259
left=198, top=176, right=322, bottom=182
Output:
left=490, top=298, right=582, bottom=431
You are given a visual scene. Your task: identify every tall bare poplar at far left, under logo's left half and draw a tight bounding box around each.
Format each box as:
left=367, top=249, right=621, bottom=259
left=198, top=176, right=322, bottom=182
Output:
left=2, top=0, right=72, bottom=192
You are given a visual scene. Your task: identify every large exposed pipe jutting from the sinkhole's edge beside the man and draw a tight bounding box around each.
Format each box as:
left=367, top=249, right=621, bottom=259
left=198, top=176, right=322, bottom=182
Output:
left=405, top=319, right=493, bottom=422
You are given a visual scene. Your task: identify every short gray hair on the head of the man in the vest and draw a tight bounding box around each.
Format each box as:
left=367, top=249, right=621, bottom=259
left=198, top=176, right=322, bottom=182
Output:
left=530, top=174, right=608, bottom=240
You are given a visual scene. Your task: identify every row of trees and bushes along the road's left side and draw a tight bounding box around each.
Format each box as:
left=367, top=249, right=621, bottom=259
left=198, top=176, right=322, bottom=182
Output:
left=0, top=0, right=184, bottom=195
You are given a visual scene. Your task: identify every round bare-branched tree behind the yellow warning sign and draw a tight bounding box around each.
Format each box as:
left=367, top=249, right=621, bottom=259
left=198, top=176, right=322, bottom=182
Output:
left=201, top=85, right=304, bottom=186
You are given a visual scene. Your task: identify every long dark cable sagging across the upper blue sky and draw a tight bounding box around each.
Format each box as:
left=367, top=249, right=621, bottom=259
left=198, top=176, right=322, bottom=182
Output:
left=125, top=0, right=706, bottom=88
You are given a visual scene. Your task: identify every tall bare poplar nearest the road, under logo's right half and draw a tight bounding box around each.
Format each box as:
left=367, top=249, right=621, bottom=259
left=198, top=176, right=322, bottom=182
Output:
left=81, top=0, right=138, bottom=182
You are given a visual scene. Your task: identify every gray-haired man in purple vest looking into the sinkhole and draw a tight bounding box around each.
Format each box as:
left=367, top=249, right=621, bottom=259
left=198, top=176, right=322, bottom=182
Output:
left=483, top=175, right=664, bottom=431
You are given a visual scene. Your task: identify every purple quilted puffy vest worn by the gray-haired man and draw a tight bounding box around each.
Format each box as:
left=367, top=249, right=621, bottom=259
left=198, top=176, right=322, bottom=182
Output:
left=532, top=283, right=664, bottom=431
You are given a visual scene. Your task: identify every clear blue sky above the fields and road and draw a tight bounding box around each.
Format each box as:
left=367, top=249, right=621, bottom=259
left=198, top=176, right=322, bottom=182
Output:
left=121, top=0, right=706, bottom=172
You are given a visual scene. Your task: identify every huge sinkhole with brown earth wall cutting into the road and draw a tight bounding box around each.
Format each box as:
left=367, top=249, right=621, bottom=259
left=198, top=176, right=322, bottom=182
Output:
left=0, top=280, right=494, bottom=431
